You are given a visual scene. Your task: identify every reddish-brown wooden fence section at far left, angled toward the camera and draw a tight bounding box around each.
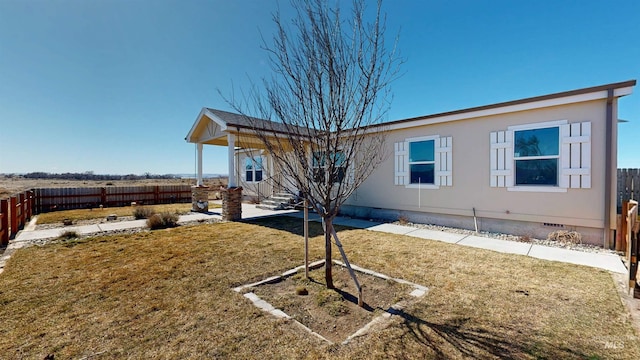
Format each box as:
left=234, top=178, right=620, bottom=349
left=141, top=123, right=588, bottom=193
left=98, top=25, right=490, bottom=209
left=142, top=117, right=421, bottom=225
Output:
left=0, top=191, right=34, bottom=246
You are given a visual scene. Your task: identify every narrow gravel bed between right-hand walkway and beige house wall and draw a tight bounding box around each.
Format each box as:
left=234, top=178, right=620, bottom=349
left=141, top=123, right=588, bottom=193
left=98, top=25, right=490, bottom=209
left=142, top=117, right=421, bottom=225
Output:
left=392, top=221, right=619, bottom=255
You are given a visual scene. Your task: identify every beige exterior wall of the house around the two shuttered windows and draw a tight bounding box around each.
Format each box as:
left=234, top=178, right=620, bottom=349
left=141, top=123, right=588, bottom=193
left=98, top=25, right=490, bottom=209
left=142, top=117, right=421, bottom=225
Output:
left=342, top=99, right=617, bottom=245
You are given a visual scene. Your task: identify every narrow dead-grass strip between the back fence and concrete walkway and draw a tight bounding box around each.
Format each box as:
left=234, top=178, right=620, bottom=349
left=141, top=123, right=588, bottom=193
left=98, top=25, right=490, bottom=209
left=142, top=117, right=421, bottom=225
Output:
left=38, top=203, right=220, bottom=224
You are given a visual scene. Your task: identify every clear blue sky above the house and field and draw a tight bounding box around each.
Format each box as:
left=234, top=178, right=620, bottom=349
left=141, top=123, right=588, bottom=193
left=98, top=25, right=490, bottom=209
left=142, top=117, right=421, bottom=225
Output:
left=0, top=0, right=640, bottom=174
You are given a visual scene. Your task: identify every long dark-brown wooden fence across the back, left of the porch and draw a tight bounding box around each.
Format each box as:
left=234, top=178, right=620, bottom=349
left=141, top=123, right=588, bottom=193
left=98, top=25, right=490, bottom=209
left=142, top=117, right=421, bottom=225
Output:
left=33, top=185, right=191, bottom=214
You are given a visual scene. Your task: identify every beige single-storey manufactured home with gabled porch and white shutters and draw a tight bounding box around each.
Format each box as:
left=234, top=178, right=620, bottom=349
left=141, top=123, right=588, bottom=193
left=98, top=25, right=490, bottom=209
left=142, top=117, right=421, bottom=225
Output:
left=186, top=80, right=636, bottom=246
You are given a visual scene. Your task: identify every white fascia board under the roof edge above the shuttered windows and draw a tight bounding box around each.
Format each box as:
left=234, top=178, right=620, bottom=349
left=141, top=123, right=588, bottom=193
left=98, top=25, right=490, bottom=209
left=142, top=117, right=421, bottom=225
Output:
left=387, top=86, right=633, bottom=130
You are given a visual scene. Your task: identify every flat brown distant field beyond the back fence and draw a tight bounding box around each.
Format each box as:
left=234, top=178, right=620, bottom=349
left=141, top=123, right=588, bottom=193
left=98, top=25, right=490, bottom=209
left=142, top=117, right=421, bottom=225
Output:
left=0, top=176, right=227, bottom=199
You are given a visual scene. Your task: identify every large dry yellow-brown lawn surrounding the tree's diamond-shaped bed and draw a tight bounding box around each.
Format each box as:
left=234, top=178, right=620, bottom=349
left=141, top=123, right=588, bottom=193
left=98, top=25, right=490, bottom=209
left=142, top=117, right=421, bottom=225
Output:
left=0, top=217, right=640, bottom=359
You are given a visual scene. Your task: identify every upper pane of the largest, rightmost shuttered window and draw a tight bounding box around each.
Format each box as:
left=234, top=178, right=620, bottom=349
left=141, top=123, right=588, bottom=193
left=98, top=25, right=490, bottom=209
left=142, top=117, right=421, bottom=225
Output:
left=513, top=127, right=560, bottom=157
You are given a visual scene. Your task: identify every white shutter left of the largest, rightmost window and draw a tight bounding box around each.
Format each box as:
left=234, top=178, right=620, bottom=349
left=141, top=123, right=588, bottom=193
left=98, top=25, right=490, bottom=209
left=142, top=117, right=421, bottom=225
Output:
left=489, top=130, right=513, bottom=187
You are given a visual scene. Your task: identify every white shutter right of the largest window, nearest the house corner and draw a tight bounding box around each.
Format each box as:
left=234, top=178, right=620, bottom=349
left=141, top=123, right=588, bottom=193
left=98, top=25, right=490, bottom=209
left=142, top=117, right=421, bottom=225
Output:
left=559, top=122, right=591, bottom=189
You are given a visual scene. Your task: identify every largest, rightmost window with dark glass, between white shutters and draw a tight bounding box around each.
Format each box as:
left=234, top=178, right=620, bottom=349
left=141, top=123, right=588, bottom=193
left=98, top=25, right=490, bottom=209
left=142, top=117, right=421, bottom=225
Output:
left=513, top=127, right=560, bottom=186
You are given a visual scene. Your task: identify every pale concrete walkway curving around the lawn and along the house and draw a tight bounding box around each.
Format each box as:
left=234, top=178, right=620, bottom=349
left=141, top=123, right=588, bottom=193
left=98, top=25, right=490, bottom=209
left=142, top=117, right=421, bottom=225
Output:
left=0, top=204, right=627, bottom=274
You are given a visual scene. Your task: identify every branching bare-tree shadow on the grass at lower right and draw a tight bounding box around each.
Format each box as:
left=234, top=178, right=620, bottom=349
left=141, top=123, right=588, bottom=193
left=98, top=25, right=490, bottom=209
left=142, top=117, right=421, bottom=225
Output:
left=388, top=308, right=589, bottom=359
